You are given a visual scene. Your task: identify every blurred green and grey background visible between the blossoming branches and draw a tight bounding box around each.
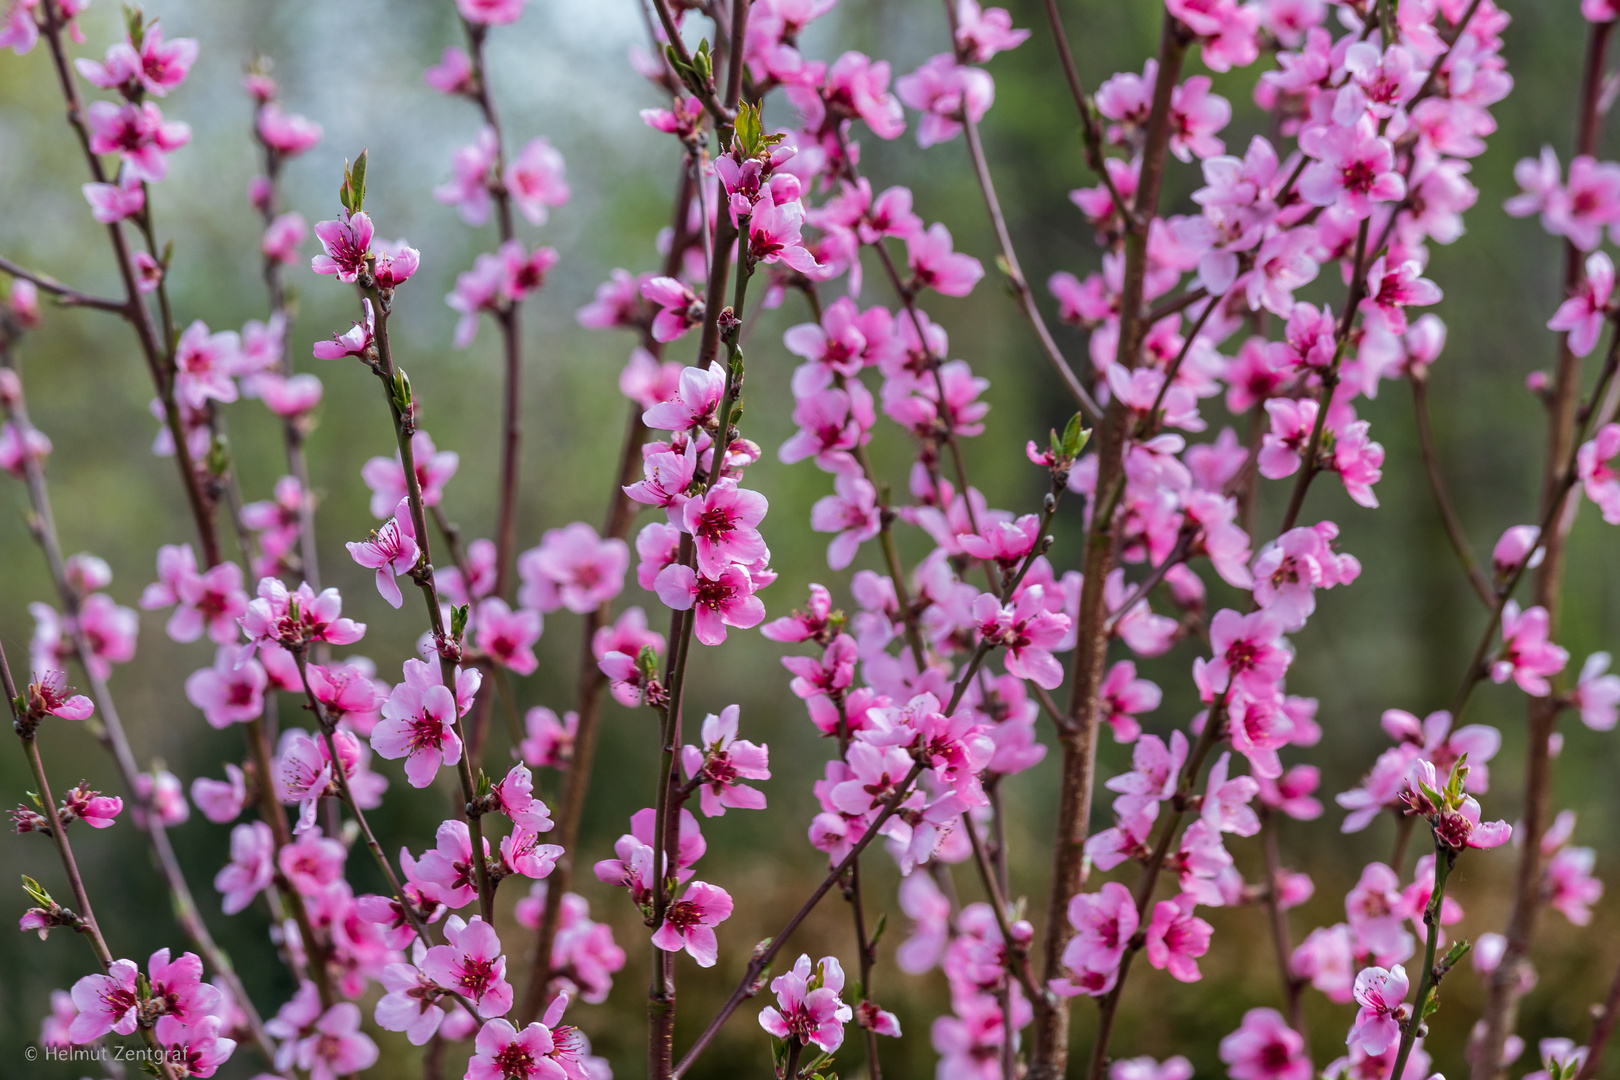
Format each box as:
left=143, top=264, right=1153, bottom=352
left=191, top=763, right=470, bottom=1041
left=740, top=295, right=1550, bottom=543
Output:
left=0, top=0, right=1620, bottom=1080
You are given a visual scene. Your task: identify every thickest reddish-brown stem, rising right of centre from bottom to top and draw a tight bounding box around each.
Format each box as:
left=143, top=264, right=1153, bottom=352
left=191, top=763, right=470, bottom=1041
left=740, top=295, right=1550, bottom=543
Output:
left=1029, top=13, right=1187, bottom=1080
